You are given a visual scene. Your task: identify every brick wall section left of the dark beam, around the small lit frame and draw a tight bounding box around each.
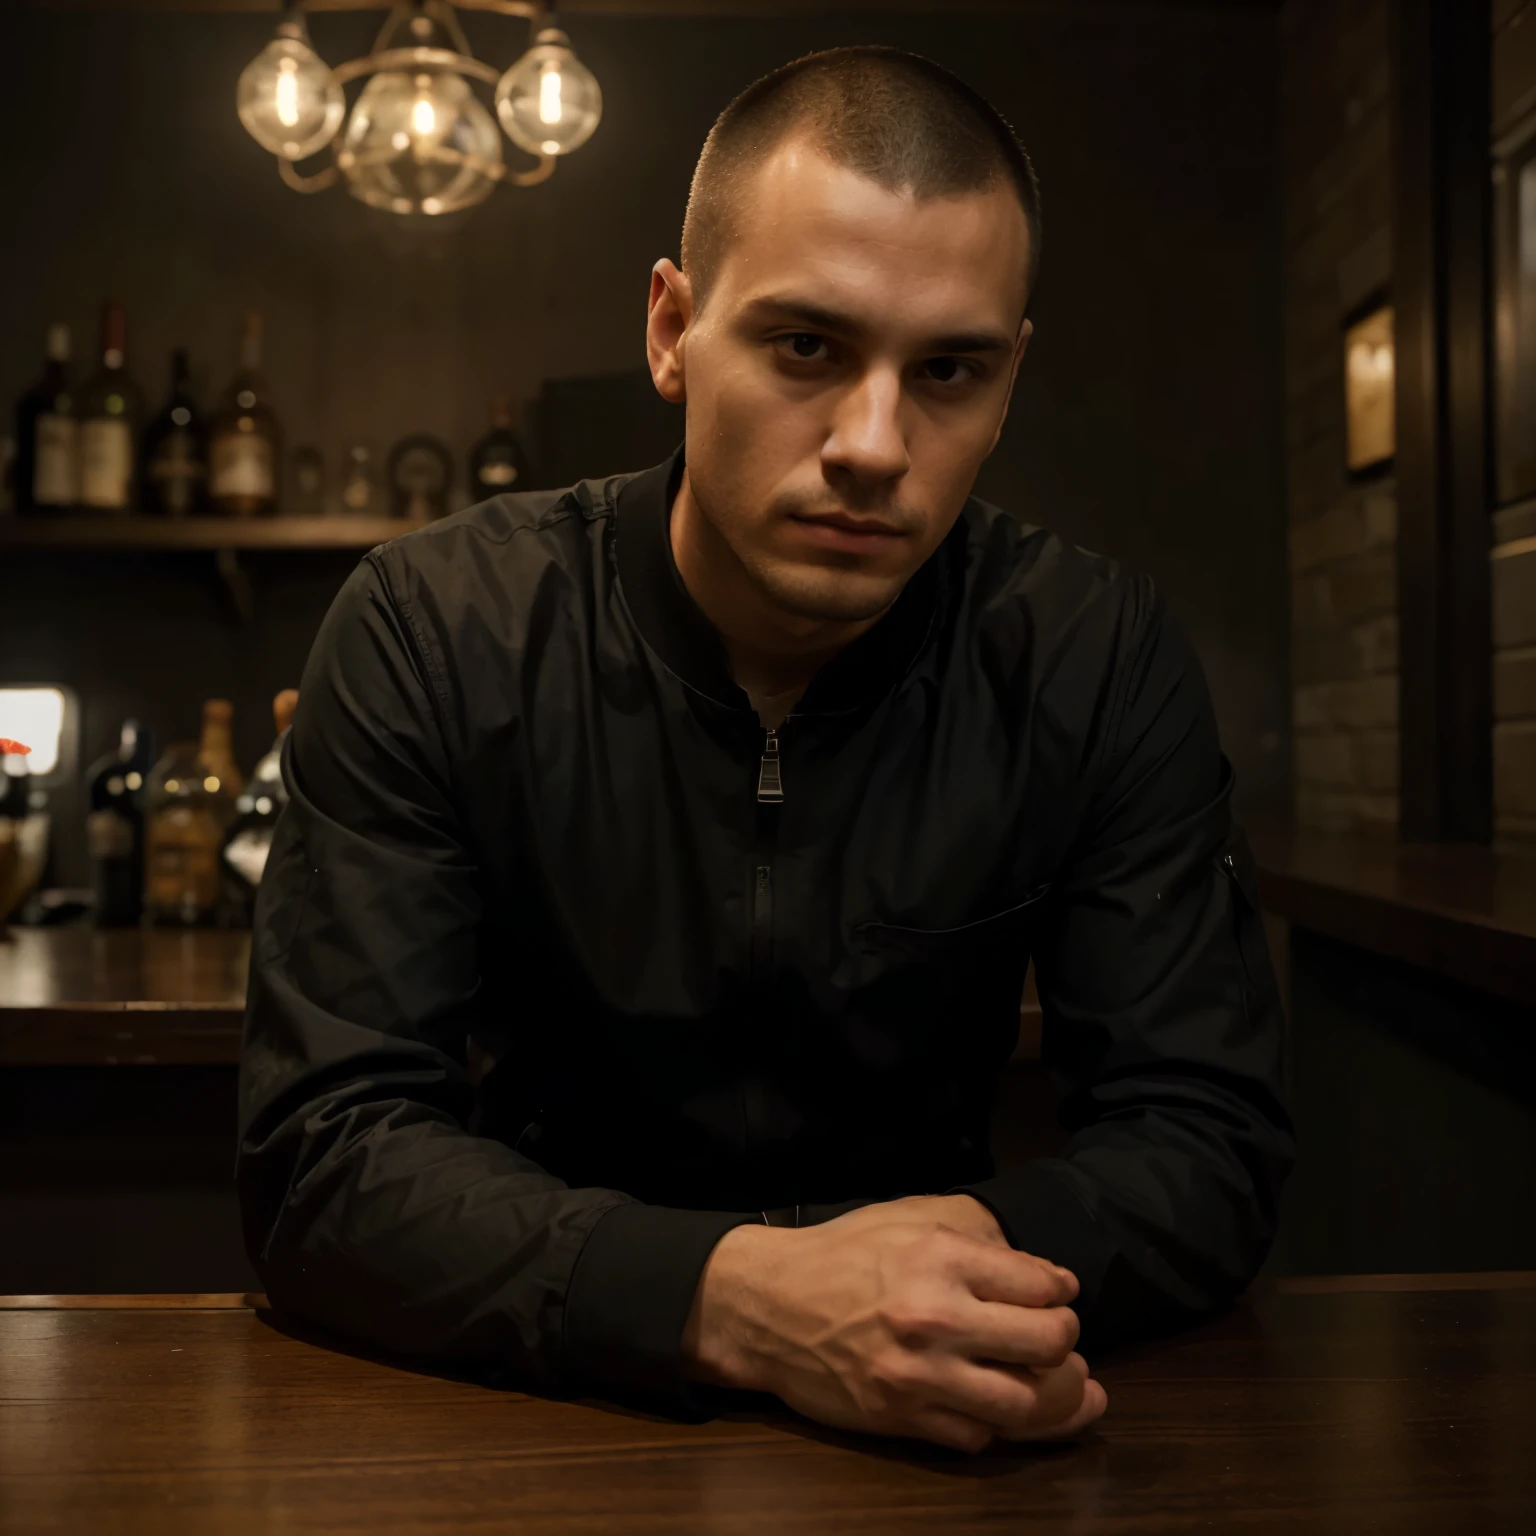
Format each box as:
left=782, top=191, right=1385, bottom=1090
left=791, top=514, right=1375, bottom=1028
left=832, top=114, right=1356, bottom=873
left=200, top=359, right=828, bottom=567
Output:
left=1283, top=0, right=1398, bottom=834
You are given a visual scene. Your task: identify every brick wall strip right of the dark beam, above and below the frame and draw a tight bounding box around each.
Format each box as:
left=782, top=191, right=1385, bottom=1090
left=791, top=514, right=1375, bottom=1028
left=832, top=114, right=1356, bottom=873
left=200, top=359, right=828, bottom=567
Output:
left=1493, top=0, right=1536, bottom=840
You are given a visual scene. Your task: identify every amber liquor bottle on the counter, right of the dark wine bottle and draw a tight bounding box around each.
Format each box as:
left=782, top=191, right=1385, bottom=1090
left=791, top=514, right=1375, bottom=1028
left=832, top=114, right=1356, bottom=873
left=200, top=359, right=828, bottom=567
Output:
left=144, top=699, right=238, bottom=928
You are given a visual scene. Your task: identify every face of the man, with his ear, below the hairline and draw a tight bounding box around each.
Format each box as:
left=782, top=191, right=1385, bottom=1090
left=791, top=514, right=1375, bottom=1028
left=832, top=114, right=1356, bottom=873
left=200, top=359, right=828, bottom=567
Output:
left=651, top=138, right=1029, bottom=622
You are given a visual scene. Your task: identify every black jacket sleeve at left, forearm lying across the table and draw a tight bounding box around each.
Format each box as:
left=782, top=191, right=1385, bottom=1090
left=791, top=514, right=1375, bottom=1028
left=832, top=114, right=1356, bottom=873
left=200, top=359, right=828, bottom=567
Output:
left=237, top=554, right=742, bottom=1410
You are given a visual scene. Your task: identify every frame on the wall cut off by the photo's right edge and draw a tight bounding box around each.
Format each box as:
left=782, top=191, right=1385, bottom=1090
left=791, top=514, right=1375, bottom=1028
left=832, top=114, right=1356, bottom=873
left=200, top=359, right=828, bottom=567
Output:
left=1493, top=115, right=1536, bottom=507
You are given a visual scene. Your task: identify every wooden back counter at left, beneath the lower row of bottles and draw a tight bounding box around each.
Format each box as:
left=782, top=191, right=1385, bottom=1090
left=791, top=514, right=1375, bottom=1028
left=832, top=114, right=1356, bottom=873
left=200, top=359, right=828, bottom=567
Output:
left=0, top=928, right=250, bottom=1066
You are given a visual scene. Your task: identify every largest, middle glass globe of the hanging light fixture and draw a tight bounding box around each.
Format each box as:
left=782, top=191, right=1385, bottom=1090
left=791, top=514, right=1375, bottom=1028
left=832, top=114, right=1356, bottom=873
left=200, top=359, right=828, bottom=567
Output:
left=336, top=71, right=501, bottom=214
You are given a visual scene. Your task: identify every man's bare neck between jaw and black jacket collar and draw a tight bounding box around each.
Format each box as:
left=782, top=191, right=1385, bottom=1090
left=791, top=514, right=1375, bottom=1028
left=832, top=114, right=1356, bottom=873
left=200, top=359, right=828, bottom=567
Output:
left=671, top=468, right=879, bottom=712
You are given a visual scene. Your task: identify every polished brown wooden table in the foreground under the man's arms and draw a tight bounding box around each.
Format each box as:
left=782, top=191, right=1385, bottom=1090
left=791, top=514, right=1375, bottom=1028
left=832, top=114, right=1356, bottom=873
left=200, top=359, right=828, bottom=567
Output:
left=0, top=1275, right=1536, bottom=1536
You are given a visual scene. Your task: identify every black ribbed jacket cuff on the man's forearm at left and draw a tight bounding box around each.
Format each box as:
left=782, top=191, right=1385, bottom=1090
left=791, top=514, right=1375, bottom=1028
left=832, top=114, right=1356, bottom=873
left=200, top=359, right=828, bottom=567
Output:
left=564, top=1201, right=762, bottom=1418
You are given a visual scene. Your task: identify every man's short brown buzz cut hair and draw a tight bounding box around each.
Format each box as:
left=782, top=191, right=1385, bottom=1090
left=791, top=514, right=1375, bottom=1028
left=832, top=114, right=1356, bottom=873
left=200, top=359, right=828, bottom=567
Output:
left=682, top=45, right=1040, bottom=307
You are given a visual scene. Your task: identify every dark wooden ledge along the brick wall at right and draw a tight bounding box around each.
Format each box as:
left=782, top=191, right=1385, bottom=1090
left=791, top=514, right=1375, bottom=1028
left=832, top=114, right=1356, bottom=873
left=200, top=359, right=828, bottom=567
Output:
left=1249, top=823, right=1536, bottom=1005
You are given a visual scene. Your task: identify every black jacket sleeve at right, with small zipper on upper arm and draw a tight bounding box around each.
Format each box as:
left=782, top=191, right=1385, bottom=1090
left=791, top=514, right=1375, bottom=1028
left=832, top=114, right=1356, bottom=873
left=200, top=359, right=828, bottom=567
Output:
left=968, top=584, right=1295, bottom=1344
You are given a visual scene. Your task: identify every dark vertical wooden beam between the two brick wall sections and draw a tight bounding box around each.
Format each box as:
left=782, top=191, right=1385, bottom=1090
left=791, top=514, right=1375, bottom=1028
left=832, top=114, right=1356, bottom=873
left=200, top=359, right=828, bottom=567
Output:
left=1392, top=0, right=1493, bottom=842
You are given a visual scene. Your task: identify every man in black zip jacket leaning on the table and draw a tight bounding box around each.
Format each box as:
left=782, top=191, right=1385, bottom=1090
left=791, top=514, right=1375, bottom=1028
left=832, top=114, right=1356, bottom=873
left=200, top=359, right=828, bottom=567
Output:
left=240, top=48, right=1292, bottom=1450
